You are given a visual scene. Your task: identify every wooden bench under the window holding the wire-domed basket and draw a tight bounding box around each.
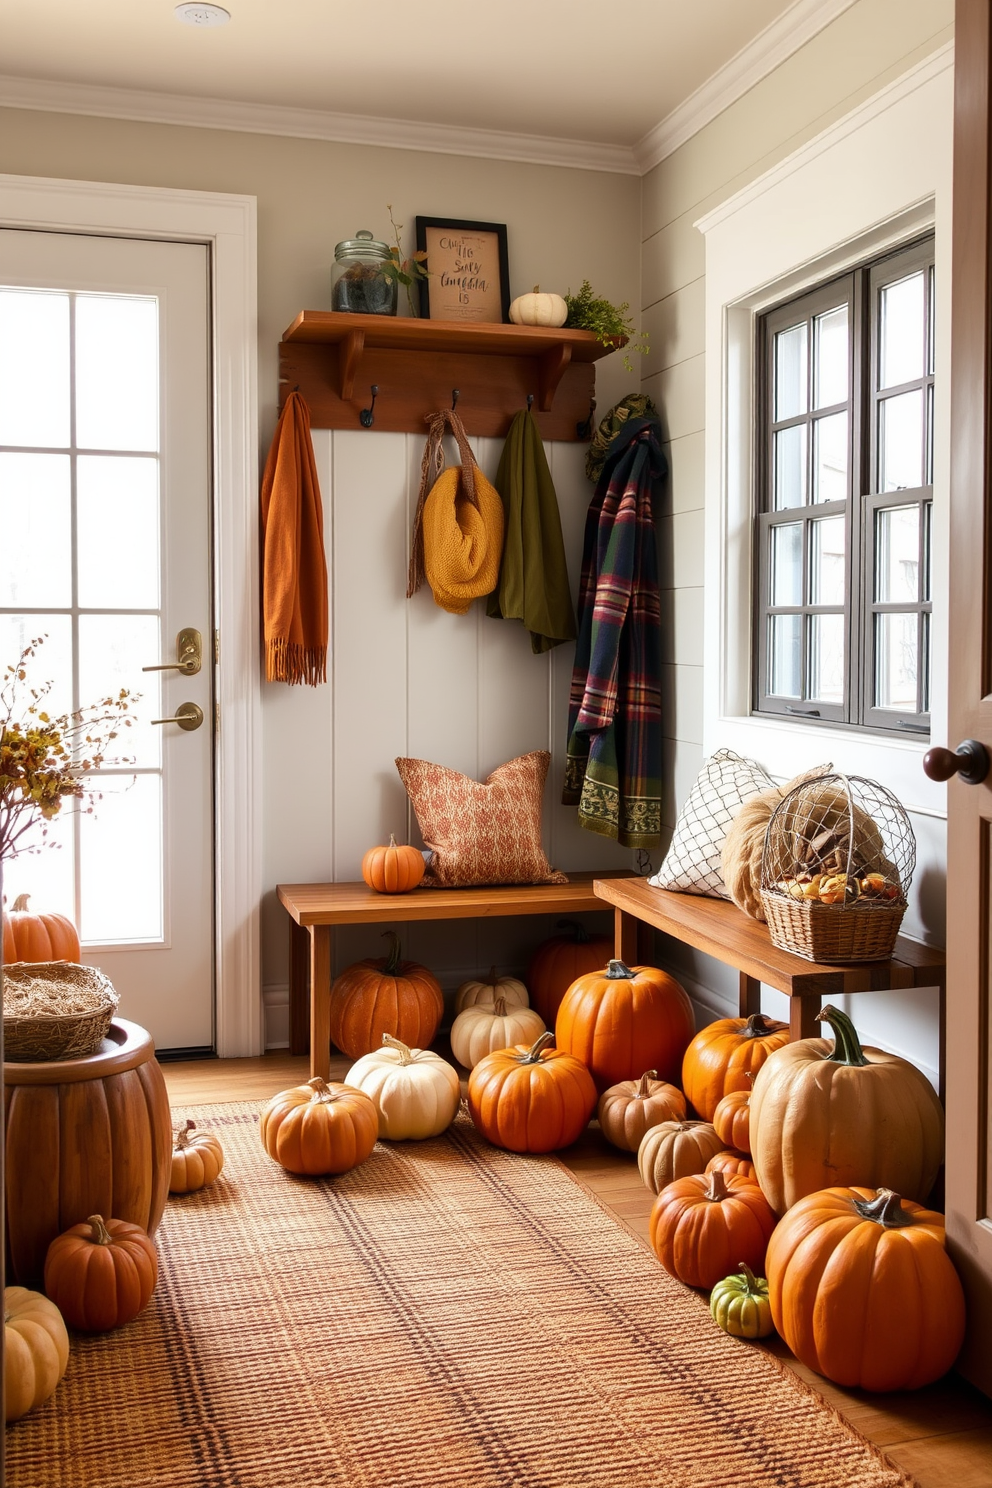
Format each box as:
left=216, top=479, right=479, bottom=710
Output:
left=593, top=878, right=947, bottom=1094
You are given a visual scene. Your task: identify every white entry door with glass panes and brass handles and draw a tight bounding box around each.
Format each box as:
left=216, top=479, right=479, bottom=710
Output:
left=0, top=229, right=214, bottom=1051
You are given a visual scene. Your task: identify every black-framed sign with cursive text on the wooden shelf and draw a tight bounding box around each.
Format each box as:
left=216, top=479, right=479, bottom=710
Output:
left=416, top=217, right=510, bottom=323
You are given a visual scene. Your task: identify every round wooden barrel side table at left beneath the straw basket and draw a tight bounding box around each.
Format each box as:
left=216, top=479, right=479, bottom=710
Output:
left=3, top=1018, right=173, bottom=1286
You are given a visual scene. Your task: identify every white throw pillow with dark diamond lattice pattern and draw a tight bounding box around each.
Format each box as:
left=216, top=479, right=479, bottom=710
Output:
left=648, top=748, right=775, bottom=899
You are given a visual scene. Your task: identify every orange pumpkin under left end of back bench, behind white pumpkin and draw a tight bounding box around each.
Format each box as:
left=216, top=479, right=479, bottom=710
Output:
left=330, top=931, right=445, bottom=1059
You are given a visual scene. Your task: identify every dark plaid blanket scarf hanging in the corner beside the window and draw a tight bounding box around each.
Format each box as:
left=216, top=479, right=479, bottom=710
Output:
left=562, top=418, right=668, bottom=848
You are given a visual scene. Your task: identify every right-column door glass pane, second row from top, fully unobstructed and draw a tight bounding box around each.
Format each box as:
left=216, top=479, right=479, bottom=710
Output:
left=76, top=455, right=159, bottom=610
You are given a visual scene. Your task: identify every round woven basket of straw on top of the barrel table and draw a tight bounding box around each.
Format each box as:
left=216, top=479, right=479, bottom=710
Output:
left=3, top=961, right=120, bottom=1064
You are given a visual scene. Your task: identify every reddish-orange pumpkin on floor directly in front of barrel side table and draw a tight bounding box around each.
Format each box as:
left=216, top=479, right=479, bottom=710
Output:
left=45, top=1214, right=159, bottom=1333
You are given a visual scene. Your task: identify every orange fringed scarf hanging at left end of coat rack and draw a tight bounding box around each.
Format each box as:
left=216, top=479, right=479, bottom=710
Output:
left=262, top=393, right=327, bottom=687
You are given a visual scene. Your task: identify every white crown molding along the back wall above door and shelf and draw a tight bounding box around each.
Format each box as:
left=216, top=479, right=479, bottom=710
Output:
left=0, top=76, right=641, bottom=176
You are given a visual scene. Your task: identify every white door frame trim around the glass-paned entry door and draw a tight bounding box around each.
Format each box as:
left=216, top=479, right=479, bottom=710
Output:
left=0, top=174, right=263, bottom=1058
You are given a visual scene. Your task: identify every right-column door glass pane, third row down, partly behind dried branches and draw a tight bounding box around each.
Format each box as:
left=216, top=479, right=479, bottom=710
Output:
left=79, top=615, right=159, bottom=768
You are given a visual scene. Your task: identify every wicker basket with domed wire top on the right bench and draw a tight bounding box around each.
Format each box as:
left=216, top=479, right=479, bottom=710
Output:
left=761, top=774, right=916, bottom=963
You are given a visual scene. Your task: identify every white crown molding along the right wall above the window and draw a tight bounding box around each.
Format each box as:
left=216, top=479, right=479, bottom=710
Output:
left=634, top=0, right=857, bottom=176
